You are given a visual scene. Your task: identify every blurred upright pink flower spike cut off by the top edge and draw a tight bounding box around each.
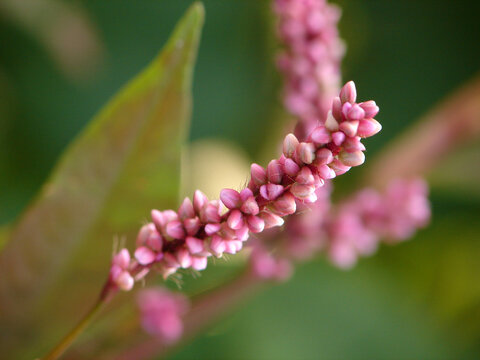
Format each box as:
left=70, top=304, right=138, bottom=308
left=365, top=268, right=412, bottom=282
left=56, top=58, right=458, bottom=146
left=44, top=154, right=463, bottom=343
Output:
left=273, top=0, right=345, bottom=140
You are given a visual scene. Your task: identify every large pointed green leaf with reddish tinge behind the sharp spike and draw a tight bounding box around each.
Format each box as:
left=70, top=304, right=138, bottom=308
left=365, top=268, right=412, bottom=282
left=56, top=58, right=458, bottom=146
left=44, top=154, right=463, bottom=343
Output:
left=0, top=3, right=204, bottom=358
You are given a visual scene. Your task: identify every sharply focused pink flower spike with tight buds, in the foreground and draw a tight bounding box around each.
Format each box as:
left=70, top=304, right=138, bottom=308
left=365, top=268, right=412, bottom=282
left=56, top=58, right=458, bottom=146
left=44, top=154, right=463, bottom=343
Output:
left=106, top=81, right=381, bottom=291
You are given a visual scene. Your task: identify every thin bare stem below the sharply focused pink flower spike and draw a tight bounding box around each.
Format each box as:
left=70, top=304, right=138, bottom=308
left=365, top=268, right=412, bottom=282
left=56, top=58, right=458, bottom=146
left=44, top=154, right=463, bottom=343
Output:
left=41, top=281, right=114, bottom=360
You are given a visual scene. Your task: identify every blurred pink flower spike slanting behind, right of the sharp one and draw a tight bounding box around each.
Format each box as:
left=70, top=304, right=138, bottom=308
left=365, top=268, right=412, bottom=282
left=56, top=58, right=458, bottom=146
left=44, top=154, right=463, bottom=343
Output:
left=250, top=179, right=430, bottom=281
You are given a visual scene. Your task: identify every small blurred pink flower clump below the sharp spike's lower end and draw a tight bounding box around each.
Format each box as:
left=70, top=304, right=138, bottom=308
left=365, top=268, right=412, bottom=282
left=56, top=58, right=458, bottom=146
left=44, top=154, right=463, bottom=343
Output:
left=137, top=287, right=190, bottom=344
